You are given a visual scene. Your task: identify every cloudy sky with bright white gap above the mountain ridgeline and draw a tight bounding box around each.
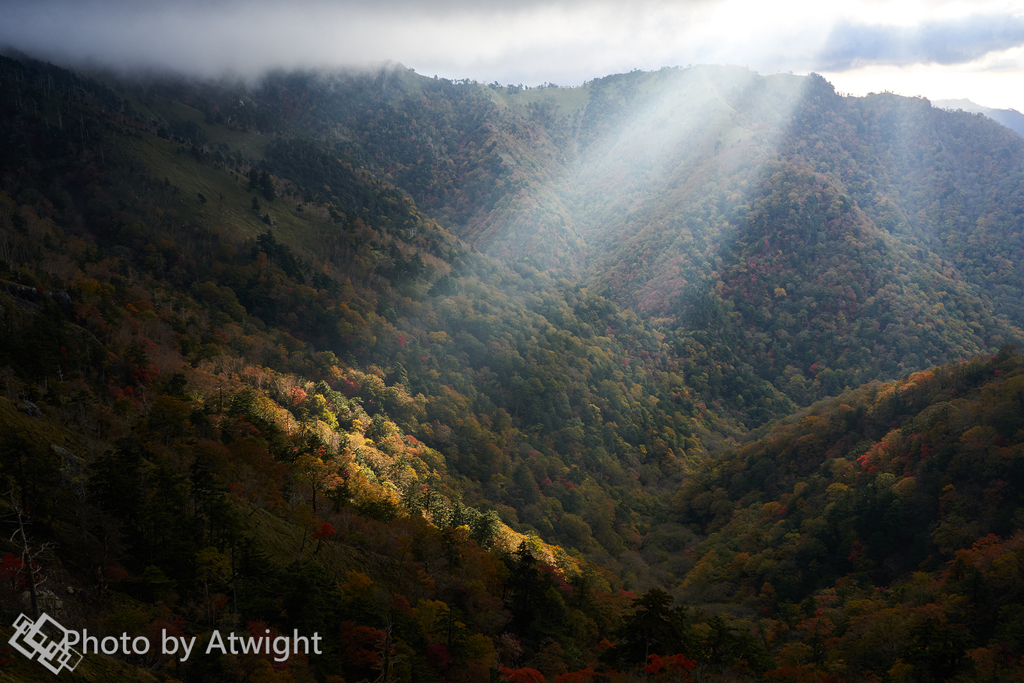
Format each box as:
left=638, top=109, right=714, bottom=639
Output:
left=0, top=0, right=1024, bottom=112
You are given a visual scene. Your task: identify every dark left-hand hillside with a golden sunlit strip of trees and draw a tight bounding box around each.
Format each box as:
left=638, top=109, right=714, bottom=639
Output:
left=0, top=53, right=753, bottom=681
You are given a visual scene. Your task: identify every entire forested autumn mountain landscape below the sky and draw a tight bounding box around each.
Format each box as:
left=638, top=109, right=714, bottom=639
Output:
left=0, top=50, right=1024, bottom=683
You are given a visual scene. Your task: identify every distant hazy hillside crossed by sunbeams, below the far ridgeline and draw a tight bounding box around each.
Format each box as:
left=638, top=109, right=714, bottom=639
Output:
left=220, top=67, right=1024, bottom=409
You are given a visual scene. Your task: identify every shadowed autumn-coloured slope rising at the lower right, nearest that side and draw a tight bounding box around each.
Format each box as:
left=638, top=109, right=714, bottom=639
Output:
left=676, top=348, right=1024, bottom=681
